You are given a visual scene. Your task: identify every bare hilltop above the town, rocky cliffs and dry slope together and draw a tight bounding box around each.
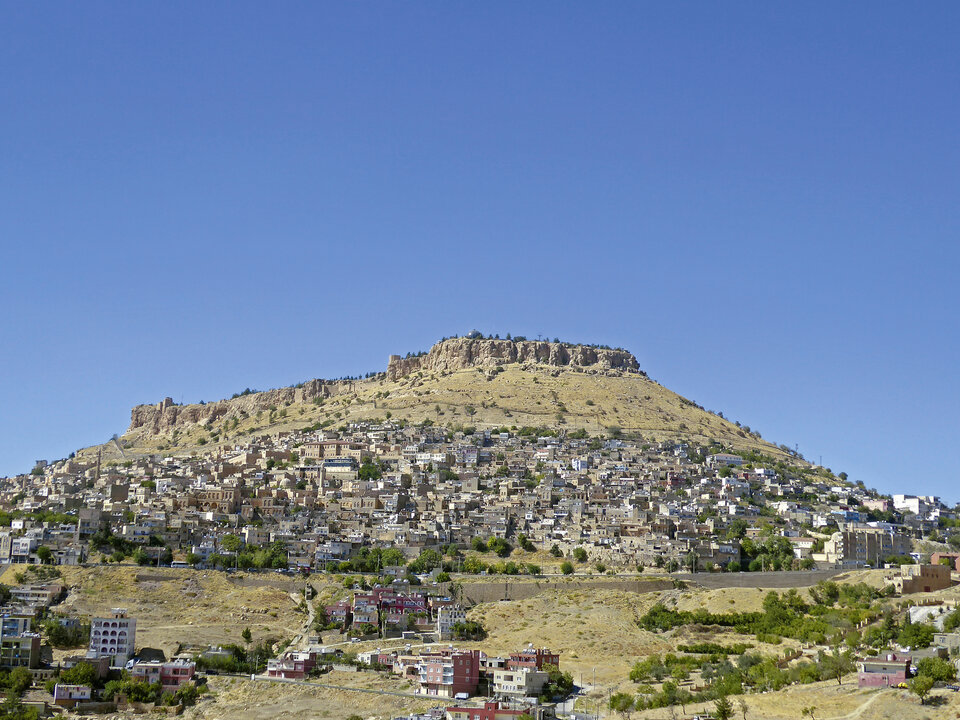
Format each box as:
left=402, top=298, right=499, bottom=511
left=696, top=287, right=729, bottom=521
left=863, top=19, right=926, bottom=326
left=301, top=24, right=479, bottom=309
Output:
left=94, top=337, right=784, bottom=456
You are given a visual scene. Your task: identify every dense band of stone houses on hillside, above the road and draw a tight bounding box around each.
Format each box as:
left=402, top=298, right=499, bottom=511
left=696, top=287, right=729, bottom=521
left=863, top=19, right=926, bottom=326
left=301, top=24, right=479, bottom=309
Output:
left=0, top=421, right=944, bottom=572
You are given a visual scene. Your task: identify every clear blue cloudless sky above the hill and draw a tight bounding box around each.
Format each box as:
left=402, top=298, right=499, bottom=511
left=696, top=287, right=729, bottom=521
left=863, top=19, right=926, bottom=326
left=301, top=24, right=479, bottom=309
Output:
left=0, top=2, right=960, bottom=501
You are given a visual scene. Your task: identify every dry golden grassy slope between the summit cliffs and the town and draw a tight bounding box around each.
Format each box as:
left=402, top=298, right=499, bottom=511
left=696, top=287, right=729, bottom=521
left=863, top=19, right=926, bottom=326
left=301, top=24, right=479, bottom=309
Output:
left=82, top=364, right=783, bottom=460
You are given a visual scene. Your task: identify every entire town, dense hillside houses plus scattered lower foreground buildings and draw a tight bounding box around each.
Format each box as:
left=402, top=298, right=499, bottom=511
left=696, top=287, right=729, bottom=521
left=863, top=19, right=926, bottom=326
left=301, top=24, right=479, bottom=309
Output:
left=0, top=420, right=960, bottom=720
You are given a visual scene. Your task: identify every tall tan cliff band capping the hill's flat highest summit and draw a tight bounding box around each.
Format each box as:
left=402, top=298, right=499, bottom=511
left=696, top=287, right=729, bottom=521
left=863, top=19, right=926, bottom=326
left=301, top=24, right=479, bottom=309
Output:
left=387, top=337, right=640, bottom=380
